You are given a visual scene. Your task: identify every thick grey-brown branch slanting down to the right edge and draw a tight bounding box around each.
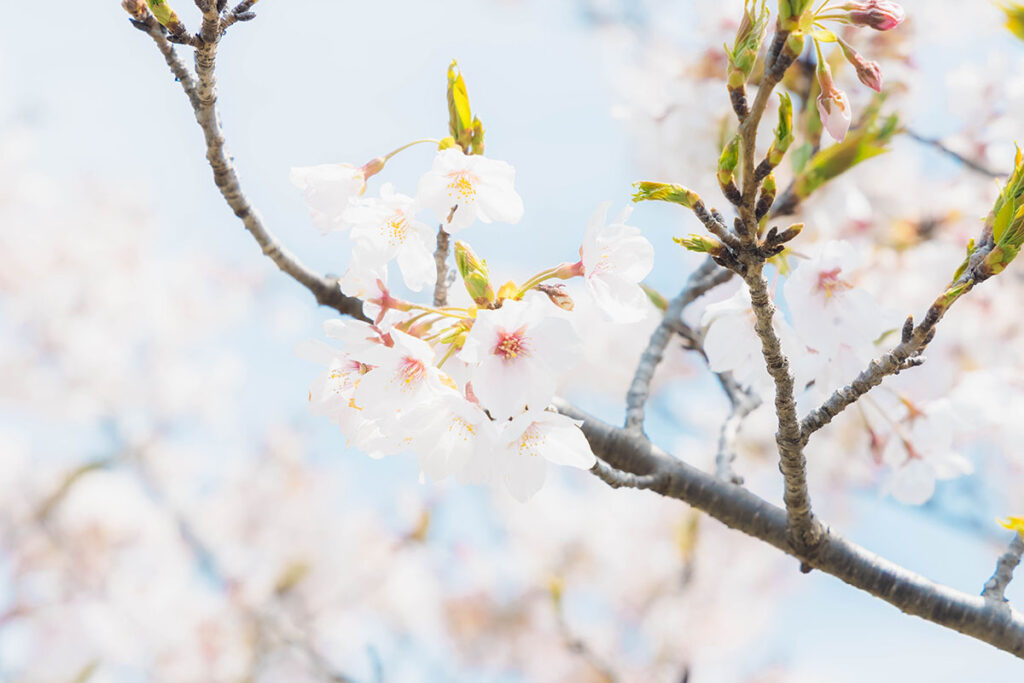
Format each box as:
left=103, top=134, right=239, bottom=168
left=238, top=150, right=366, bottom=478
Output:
left=556, top=401, right=1024, bottom=658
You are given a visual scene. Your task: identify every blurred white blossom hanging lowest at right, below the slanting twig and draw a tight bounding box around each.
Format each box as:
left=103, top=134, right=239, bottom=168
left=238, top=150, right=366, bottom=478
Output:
left=882, top=399, right=974, bottom=505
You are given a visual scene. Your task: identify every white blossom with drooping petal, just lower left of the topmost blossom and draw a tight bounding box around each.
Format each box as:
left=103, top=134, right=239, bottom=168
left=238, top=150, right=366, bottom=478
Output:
left=343, top=183, right=436, bottom=292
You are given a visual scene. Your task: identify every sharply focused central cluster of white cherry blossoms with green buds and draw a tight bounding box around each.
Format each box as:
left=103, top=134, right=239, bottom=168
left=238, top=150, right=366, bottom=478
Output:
left=292, top=68, right=654, bottom=500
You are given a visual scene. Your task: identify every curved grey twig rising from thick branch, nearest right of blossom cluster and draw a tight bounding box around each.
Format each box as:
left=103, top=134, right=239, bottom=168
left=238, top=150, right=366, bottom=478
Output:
left=626, top=259, right=732, bottom=432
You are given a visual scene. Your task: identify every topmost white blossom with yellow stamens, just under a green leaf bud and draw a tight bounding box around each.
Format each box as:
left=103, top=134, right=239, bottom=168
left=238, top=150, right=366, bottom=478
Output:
left=416, top=147, right=522, bottom=232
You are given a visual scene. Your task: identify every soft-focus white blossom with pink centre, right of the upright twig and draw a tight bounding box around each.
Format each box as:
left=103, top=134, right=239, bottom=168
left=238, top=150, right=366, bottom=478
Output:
left=782, top=242, right=888, bottom=360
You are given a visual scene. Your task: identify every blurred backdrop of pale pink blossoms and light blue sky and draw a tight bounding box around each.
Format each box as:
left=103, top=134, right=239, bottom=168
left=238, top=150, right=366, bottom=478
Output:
left=0, top=0, right=1024, bottom=683
